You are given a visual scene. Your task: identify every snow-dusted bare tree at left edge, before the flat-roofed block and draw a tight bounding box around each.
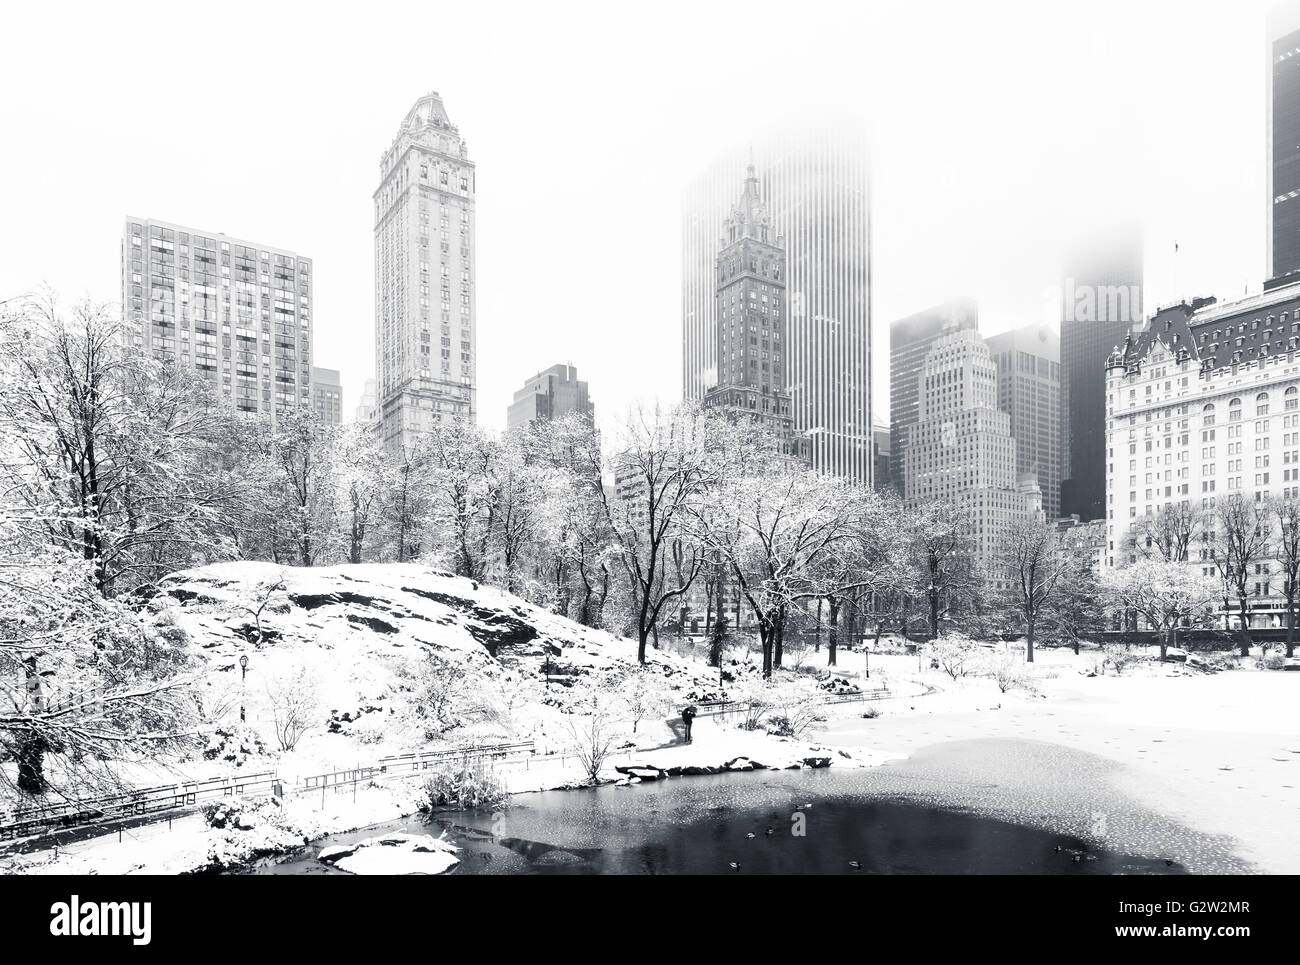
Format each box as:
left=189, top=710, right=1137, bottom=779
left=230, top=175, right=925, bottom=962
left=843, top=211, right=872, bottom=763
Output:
left=0, top=297, right=246, bottom=594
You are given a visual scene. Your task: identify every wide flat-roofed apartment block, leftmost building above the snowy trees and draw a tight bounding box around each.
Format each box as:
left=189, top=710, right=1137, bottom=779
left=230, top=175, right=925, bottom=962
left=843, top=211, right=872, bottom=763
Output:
left=121, top=217, right=312, bottom=414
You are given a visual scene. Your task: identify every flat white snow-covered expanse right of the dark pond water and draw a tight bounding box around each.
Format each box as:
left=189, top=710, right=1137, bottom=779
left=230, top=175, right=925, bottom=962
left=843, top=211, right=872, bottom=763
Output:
left=820, top=650, right=1300, bottom=874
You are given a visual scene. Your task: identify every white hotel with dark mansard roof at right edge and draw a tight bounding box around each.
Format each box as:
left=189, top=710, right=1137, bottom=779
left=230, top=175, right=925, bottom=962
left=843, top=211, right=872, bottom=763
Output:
left=1105, top=281, right=1300, bottom=626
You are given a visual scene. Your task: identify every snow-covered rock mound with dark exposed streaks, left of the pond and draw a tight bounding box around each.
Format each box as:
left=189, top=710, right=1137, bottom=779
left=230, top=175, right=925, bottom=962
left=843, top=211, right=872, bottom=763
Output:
left=151, top=562, right=715, bottom=773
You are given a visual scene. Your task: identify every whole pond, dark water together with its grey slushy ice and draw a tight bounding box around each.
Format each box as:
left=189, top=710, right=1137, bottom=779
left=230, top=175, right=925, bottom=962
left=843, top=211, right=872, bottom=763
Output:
left=245, top=740, right=1248, bottom=874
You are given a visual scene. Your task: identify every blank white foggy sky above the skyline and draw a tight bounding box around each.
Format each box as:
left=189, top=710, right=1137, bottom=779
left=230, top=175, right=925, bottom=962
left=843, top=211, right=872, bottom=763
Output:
left=0, top=0, right=1266, bottom=428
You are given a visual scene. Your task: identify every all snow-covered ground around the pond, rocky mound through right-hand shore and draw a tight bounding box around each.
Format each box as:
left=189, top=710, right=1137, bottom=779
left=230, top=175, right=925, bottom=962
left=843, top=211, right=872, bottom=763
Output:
left=0, top=563, right=1300, bottom=874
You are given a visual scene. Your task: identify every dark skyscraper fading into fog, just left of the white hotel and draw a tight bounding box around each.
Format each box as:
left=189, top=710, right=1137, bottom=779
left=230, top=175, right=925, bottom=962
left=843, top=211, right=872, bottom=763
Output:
left=1061, top=228, right=1144, bottom=522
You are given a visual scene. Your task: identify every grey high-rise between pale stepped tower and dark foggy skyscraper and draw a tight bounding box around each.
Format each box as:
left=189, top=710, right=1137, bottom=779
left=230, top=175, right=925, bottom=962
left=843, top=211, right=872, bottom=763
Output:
left=984, top=325, right=1065, bottom=519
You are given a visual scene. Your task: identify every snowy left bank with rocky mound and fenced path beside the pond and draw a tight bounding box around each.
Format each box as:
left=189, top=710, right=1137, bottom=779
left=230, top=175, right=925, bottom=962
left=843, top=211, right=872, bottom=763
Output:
left=0, top=563, right=889, bottom=874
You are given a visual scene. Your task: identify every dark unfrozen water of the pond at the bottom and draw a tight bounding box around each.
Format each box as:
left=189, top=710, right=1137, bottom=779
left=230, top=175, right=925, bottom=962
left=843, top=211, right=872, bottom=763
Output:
left=250, top=766, right=1186, bottom=874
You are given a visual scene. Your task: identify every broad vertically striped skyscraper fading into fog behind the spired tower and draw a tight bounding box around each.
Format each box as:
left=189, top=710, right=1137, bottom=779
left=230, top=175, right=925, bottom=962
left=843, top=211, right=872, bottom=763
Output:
left=681, top=122, right=872, bottom=483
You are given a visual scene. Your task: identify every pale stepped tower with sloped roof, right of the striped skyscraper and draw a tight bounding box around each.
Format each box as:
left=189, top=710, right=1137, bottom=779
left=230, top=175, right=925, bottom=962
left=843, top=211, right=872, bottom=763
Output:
left=904, top=329, right=1043, bottom=589
